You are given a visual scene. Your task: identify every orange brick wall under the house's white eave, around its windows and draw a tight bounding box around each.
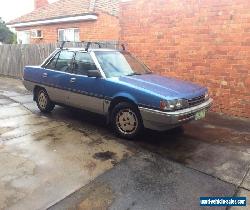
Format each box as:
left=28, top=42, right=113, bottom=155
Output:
left=16, top=12, right=120, bottom=43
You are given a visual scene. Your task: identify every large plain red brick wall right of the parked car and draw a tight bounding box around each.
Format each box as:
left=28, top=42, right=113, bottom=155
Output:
left=120, top=0, right=250, bottom=117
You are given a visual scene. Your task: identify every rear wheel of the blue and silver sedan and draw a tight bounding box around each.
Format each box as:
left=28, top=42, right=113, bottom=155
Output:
left=35, top=88, right=55, bottom=113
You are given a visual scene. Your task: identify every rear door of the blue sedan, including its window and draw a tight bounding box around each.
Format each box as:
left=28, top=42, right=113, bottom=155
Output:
left=42, top=50, right=75, bottom=105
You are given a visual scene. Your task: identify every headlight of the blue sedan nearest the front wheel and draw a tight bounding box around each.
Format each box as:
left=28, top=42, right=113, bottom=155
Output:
left=160, top=99, right=188, bottom=111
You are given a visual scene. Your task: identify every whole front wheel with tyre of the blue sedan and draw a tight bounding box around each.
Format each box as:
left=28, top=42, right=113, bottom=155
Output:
left=111, top=102, right=143, bottom=139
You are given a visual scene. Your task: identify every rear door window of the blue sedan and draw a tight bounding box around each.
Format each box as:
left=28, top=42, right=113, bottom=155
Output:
left=55, top=50, right=75, bottom=72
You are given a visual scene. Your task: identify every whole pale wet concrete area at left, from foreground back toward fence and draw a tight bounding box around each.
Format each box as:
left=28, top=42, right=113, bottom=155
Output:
left=0, top=78, right=134, bottom=210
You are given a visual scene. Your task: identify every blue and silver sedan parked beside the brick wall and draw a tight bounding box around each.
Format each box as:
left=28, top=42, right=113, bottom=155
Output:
left=23, top=45, right=213, bottom=139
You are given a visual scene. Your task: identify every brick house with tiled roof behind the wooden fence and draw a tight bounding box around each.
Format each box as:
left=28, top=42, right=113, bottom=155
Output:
left=8, top=0, right=120, bottom=44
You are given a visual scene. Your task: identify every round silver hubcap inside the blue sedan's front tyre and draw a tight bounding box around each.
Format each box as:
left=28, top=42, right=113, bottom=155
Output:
left=116, top=109, right=138, bottom=134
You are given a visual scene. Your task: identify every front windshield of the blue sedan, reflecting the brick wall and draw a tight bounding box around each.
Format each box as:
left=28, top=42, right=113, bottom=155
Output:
left=95, top=51, right=151, bottom=78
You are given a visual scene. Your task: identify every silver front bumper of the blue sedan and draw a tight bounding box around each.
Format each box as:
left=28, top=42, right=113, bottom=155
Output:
left=139, top=99, right=213, bottom=131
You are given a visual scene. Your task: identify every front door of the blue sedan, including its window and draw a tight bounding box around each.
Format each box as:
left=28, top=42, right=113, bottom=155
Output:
left=67, top=52, right=104, bottom=114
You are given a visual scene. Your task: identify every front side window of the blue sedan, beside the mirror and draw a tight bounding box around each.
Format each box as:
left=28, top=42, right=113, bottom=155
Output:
left=73, top=52, right=97, bottom=75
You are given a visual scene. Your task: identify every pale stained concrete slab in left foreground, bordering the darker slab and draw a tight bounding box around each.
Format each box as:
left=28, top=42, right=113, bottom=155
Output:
left=0, top=125, right=132, bottom=209
